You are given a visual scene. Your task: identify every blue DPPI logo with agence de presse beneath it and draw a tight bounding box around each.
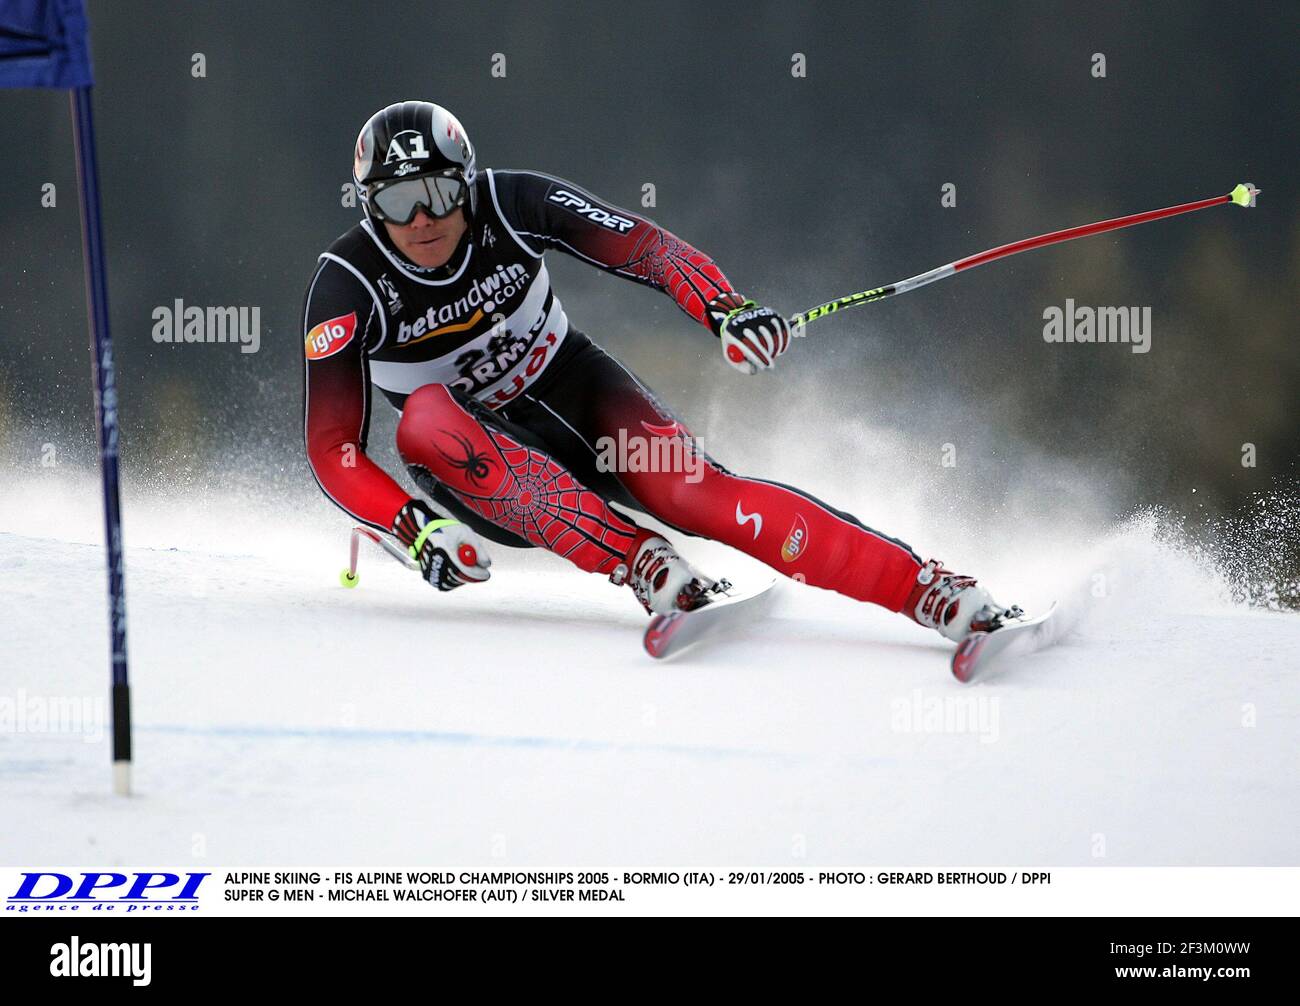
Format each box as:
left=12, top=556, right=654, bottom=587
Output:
left=5, top=873, right=212, bottom=912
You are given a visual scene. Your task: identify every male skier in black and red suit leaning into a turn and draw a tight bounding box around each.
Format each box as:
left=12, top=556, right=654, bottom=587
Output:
left=303, top=101, right=1008, bottom=641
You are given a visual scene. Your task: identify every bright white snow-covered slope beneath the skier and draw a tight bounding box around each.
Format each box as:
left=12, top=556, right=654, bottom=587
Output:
left=0, top=471, right=1300, bottom=868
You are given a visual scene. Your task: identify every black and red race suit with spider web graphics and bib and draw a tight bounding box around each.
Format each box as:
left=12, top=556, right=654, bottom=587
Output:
left=303, top=169, right=920, bottom=611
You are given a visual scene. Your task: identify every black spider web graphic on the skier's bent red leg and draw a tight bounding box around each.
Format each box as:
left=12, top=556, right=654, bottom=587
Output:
left=455, top=429, right=638, bottom=572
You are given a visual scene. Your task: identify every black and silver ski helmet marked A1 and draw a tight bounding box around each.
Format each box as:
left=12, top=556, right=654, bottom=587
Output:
left=352, top=101, right=478, bottom=218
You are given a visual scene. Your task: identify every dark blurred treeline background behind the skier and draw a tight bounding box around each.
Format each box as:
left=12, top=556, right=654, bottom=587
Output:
left=0, top=0, right=1300, bottom=590
